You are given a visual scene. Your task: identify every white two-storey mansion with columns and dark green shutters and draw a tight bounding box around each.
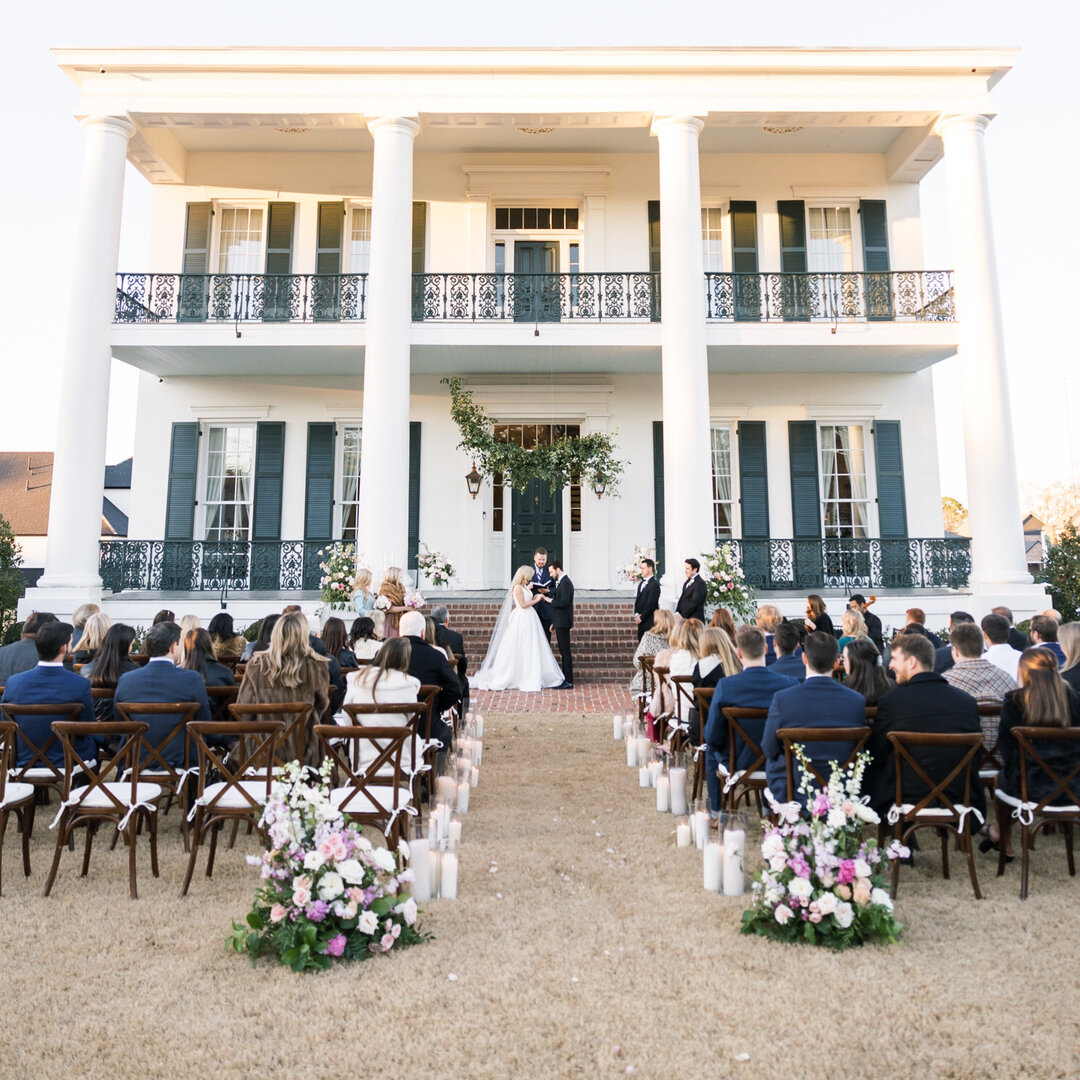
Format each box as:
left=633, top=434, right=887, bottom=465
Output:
left=16, top=48, right=1048, bottom=622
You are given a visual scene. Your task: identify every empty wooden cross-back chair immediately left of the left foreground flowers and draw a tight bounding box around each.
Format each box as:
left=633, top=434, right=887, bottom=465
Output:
left=180, top=720, right=285, bottom=897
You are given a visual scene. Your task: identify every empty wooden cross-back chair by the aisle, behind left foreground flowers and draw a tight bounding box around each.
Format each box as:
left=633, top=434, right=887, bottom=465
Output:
left=315, top=721, right=419, bottom=851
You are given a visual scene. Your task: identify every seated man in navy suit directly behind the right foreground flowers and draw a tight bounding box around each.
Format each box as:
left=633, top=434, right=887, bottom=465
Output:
left=761, top=630, right=866, bottom=802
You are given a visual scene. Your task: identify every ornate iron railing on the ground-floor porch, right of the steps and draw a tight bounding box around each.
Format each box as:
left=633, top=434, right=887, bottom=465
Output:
left=731, top=537, right=971, bottom=592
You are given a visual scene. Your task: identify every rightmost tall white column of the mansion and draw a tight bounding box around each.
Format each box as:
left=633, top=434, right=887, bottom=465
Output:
left=937, top=116, right=1031, bottom=592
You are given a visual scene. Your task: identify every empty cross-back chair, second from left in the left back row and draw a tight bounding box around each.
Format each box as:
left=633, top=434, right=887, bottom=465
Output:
left=42, top=720, right=161, bottom=900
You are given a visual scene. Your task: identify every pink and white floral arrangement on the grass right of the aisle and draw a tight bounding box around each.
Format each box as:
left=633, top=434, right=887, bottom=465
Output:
left=742, top=746, right=910, bottom=949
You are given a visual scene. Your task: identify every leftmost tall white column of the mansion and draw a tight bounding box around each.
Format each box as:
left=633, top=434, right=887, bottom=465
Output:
left=37, top=117, right=135, bottom=596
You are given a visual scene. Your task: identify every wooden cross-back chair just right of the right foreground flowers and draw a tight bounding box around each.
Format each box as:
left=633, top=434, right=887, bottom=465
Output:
left=888, top=731, right=983, bottom=900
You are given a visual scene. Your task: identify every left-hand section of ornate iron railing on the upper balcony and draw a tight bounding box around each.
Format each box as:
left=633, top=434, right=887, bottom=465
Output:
left=113, top=273, right=367, bottom=323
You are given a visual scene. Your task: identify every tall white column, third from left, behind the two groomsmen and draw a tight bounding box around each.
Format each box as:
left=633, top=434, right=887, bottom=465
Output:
left=652, top=116, right=714, bottom=595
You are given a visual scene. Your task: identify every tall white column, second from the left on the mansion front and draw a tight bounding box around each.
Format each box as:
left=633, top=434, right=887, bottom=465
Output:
left=356, top=117, right=420, bottom=572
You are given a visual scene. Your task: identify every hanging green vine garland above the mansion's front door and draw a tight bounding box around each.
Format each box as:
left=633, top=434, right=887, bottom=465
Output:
left=442, top=378, right=627, bottom=495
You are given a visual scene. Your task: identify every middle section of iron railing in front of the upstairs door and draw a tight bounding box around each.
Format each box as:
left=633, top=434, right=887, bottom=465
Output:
left=413, top=272, right=660, bottom=323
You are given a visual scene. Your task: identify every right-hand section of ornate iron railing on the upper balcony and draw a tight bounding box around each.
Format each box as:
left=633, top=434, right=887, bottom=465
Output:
left=705, top=270, right=956, bottom=323
